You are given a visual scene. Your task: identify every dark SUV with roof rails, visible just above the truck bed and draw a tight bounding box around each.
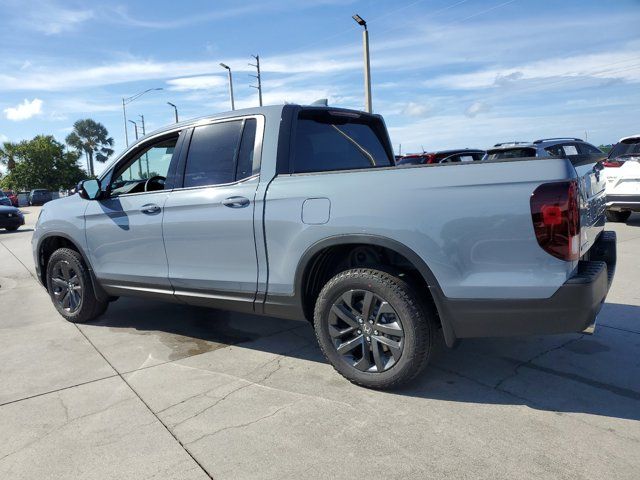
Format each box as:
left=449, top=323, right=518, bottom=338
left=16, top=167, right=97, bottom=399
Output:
left=484, top=138, right=604, bottom=160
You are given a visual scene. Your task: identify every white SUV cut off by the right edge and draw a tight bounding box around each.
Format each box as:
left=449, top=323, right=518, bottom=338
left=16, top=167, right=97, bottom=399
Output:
left=602, top=134, right=640, bottom=222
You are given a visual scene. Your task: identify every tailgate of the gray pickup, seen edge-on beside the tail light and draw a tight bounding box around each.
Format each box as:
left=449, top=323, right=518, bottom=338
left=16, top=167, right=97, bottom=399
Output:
left=569, top=155, right=606, bottom=255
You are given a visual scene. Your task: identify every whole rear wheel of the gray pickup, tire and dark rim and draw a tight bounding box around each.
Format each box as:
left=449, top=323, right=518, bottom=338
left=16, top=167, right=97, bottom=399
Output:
left=314, top=268, right=435, bottom=389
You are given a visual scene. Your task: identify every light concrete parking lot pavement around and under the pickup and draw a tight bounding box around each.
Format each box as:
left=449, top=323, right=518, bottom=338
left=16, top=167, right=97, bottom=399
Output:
left=0, top=207, right=640, bottom=479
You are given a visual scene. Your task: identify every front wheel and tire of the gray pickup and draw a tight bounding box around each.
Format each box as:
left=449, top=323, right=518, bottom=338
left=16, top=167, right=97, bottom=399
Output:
left=47, top=248, right=108, bottom=323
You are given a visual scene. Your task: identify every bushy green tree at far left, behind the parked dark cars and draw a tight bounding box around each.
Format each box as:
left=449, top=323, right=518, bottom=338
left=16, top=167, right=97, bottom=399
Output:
left=1, top=135, right=87, bottom=190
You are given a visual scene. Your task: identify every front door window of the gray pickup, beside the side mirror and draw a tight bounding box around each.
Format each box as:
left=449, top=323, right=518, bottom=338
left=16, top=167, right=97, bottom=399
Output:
left=110, top=136, right=178, bottom=195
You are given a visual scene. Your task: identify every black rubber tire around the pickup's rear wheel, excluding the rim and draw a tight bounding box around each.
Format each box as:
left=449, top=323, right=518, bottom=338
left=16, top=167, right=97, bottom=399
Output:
left=314, top=270, right=431, bottom=388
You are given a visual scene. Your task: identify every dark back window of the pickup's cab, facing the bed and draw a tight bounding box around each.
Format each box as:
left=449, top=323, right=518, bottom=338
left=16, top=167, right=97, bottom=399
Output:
left=293, top=110, right=394, bottom=173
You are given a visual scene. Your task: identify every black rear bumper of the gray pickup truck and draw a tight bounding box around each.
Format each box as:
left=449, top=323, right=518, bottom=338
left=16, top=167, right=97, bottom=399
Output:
left=440, top=232, right=616, bottom=344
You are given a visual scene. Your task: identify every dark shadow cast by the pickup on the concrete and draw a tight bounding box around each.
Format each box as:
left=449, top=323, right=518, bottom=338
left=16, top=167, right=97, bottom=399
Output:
left=91, top=298, right=640, bottom=420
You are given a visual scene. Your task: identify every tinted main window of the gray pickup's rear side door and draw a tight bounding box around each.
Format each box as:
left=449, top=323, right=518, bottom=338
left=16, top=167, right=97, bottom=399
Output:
left=184, top=120, right=242, bottom=187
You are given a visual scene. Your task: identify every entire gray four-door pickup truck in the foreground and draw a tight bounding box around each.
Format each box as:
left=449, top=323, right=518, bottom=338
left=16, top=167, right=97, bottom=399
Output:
left=33, top=105, right=616, bottom=388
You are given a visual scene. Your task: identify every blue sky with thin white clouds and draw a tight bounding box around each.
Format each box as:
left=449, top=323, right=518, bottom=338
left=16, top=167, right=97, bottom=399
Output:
left=0, top=0, right=640, bottom=169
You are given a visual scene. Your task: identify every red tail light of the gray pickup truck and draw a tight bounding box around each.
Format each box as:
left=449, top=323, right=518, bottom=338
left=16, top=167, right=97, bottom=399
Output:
left=530, top=180, right=580, bottom=261
